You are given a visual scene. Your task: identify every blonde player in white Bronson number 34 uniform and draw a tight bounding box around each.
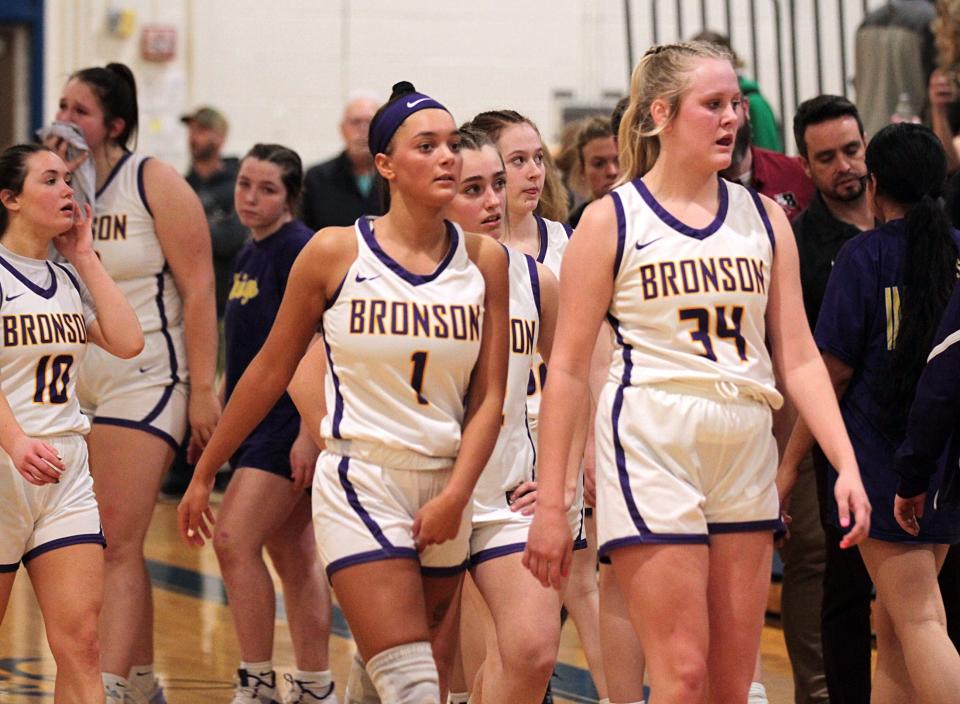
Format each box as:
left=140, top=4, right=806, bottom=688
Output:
left=525, top=43, right=870, bottom=704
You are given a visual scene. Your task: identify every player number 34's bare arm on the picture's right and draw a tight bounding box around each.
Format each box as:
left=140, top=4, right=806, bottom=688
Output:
left=763, top=197, right=870, bottom=547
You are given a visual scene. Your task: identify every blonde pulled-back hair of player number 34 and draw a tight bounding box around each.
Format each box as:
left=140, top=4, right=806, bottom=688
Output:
left=617, top=42, right=733, bottom=185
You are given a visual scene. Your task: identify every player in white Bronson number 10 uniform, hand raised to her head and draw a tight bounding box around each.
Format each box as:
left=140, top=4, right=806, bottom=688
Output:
left=0, top=145, right=143, bottom=704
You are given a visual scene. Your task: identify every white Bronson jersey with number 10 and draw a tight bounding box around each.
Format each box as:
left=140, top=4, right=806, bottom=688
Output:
left=0, top=245, right=96, bottom=437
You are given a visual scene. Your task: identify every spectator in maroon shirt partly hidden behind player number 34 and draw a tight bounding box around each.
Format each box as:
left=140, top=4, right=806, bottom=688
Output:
left=721, top=96, right=815, bottom=220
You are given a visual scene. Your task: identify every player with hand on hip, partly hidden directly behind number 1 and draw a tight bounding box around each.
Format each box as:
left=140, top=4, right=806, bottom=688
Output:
left=447, top=125, right=579, bottom=704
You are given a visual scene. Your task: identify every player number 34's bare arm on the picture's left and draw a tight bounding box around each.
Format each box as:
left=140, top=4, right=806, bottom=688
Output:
left=523, top=198, right=617, bottom=588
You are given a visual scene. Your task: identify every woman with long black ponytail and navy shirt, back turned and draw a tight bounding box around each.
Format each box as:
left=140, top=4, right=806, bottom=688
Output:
left=778, top=124, right=960, bottom=703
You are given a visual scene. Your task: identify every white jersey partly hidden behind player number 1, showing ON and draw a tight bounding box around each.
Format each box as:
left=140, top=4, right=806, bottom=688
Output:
left=474, top=248, right=540, bottom=508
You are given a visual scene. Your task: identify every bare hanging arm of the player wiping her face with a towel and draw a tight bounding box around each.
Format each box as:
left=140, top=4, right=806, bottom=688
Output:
left=143, top=159, right=220, bottom=447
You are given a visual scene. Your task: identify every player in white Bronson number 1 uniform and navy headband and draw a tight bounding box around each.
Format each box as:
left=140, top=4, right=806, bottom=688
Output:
left=180, top=83, right=509, bottom=704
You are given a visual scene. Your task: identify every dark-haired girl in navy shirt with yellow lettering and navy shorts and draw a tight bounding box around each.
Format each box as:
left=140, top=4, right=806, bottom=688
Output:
left=182, top=144, right=336, bottom=704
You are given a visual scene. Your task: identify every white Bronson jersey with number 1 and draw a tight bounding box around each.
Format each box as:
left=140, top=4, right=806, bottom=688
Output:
left=321, top=218, right=485, bottom=469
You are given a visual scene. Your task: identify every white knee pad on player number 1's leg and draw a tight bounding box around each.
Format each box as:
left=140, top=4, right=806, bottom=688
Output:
left=367, top=641, right=440, bottom=704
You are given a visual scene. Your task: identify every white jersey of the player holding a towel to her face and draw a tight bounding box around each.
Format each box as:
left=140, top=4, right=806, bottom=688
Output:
left=93, top=153, right=182, bottom=334
